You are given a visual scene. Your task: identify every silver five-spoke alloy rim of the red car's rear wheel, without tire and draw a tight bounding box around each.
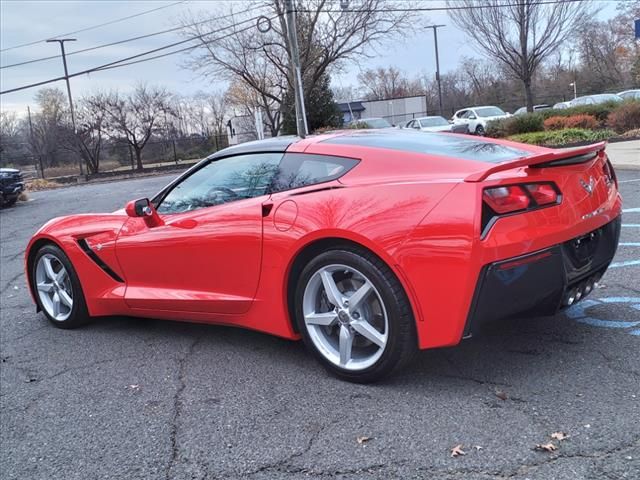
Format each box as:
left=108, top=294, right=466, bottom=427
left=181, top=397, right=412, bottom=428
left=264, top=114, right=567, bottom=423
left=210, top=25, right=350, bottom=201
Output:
left=302, top=265, right=389, bottom=371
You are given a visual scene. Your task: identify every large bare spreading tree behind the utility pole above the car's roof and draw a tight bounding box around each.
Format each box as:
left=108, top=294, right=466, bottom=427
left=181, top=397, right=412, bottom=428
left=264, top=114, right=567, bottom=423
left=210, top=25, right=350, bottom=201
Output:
left=183, top=0, right=416, bottom=135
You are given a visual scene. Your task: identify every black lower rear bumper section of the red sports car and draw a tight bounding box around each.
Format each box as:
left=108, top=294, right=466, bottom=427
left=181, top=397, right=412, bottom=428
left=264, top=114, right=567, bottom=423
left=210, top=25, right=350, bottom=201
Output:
left=463, top=217, right=621, bottom=337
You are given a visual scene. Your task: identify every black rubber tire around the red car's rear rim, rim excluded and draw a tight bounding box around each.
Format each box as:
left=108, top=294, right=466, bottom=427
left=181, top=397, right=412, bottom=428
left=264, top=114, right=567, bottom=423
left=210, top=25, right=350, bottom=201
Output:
left=294, top=247, right=417, bottom=383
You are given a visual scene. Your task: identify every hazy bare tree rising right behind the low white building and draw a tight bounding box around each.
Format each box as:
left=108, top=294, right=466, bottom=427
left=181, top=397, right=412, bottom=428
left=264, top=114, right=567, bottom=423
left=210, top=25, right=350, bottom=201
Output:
left=358, top=66, right=424, bottom=100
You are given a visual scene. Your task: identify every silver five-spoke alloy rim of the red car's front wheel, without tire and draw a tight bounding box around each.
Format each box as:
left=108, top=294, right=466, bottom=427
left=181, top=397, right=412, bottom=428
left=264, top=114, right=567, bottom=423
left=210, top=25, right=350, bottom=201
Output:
left=36, top=253, right=73, bottom=322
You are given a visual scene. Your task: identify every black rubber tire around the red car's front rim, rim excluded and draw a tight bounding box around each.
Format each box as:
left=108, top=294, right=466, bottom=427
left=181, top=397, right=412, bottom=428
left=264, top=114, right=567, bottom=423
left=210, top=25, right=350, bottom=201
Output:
left=30, top=244, right=91, bottom=329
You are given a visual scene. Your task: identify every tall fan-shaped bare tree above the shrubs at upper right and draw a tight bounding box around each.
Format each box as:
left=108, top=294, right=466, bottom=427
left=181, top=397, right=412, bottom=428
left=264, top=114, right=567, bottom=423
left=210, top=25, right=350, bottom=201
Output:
left=447, top=0, right=592, bottom=112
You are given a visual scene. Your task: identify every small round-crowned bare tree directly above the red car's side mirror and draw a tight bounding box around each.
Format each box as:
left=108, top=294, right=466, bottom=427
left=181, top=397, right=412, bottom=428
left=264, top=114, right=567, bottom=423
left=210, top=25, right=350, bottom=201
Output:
left=89, top=84, right=173, bottom=170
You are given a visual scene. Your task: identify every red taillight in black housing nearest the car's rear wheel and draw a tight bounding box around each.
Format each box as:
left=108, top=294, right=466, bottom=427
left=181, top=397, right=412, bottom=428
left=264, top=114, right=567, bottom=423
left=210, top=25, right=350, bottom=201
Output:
left=482, top=182, right=562, bottom=237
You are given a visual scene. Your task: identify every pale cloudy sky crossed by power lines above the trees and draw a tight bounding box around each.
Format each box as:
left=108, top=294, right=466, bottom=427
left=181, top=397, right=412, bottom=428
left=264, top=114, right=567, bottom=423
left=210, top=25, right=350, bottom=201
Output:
left=0, top=0, right=618, bottom=116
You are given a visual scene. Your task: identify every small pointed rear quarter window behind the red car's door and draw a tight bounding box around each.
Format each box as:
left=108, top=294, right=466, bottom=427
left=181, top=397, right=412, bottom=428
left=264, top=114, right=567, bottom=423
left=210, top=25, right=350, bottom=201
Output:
left=271, top=153, right=358, bottom=192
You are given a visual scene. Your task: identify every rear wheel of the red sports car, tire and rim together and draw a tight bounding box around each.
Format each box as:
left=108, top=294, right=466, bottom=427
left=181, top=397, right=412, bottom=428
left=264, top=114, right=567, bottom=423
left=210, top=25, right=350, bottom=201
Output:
left=295, top=249, right=417, bottom=383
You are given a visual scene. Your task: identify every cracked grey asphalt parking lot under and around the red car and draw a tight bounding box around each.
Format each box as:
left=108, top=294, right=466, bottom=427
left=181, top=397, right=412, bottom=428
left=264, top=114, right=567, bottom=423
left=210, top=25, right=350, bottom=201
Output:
left=0, top=170, right=640, bottom=480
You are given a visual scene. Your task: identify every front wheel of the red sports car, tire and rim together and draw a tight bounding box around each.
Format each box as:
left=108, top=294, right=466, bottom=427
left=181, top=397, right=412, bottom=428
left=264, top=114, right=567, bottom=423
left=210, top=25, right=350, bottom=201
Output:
left=31, top=245, right=89, bottom=328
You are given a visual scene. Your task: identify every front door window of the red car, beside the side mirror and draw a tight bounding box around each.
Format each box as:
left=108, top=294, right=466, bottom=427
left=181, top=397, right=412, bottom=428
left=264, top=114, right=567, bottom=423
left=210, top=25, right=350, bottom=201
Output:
left=158, top=153, right=282, bottom=213
